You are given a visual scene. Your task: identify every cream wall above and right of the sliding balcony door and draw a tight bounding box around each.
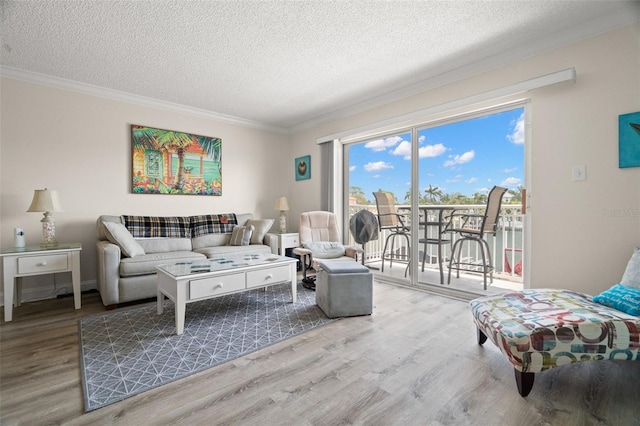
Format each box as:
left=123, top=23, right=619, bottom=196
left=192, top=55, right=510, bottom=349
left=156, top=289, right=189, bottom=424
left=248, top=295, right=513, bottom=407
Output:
left=290, top=24, right=640, bottom=294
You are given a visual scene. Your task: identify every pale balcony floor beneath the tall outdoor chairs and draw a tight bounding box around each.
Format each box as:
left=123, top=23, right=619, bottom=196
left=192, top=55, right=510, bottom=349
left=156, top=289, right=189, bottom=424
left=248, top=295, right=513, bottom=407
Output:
left=366, top=261, right=523, bottom=300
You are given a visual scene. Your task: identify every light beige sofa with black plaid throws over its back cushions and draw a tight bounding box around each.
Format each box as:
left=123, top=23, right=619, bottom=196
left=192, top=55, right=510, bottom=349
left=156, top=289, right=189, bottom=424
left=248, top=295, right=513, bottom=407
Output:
left=96, top=213, right=277, bottom=308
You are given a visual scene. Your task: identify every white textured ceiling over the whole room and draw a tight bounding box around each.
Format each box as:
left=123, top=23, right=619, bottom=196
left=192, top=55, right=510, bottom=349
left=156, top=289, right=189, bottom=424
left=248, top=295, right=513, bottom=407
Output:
left=0, top=0, right=640, bottom=129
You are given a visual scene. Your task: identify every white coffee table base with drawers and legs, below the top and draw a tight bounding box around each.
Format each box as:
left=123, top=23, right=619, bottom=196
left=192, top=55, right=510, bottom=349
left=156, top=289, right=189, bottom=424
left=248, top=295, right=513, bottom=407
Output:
left=157, top=258, right=298, bottom=335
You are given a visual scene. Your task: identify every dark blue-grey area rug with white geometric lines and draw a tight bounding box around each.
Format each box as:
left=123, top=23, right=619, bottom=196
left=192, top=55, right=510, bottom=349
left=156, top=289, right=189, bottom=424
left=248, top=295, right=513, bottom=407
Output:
left=78, top=284, right=335, bottom=412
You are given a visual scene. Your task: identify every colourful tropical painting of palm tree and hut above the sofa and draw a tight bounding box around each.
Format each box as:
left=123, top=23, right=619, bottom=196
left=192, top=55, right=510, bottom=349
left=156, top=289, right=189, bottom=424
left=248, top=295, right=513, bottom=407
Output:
left=131, top=124, right=222, bottom=195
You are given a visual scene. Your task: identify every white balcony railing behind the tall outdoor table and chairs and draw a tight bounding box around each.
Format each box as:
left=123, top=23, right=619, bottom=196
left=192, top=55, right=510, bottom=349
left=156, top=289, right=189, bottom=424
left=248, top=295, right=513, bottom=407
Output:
left=348, top=204, right=524, bottom=282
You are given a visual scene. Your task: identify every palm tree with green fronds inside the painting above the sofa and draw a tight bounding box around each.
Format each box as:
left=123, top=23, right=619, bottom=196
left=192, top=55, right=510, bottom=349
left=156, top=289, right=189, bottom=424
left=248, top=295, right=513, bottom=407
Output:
left=132, top=127, right=222, bottom=190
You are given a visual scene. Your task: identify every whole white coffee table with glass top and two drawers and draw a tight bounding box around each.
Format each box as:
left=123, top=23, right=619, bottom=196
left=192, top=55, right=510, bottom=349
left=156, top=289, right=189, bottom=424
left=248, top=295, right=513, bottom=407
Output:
left=156, top=253, right=298, bottom=334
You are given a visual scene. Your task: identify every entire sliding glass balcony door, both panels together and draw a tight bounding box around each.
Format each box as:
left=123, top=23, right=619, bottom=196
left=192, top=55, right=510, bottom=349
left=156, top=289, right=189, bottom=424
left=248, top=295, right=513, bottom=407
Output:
left=343, top=105, right=526, bottom=294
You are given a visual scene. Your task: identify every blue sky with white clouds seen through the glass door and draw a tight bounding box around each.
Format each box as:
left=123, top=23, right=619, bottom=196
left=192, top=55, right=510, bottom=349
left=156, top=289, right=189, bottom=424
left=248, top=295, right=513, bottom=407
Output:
left=349, top=108, right=524, bottom=201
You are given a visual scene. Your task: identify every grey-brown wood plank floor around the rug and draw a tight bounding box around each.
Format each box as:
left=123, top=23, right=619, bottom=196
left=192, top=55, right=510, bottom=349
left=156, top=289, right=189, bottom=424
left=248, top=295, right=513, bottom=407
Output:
left=0, top=283, right=640, bottom=426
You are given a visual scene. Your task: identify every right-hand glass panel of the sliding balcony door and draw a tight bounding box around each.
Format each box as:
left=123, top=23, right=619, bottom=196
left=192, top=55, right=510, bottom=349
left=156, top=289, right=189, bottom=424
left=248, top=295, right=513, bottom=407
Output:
left=417, top=107, right=525, bottom=289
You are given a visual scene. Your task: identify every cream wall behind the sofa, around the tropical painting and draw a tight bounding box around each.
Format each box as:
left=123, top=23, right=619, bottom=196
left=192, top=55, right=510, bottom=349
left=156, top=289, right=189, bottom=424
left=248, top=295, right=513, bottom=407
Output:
left=0, top=78, right=294, bottom=298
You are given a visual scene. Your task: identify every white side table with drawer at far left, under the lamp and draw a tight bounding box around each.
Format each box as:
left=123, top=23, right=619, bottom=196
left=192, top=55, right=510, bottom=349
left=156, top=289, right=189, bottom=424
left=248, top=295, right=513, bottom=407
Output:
left=0, top=243, right=82, bottom=322
